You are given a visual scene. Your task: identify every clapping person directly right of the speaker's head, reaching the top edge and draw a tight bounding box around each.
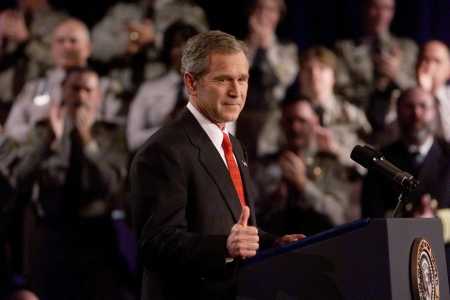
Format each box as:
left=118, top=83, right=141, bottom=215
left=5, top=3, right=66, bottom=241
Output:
left=236, top=0, right=298, bottom=160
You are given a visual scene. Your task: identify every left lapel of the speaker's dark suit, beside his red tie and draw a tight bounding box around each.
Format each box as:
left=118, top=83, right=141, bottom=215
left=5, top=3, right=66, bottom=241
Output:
left=180, top=110, right=242, bottom=222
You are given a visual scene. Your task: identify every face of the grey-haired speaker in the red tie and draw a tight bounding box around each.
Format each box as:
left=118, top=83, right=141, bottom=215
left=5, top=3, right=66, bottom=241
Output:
left=185, top=52, right=249, bottom=125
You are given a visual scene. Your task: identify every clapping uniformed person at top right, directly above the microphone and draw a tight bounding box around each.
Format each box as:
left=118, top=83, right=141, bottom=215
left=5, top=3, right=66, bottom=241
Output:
left=336, top=0, right=417, bottom=109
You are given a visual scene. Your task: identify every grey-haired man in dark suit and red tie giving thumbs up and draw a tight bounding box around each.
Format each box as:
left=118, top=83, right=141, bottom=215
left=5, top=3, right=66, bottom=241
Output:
left=130, top=31, right=301, bottom=299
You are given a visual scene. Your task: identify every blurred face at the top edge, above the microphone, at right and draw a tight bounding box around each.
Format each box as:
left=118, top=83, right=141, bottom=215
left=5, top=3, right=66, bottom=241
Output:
left=366, top=0, right=395, bottom=34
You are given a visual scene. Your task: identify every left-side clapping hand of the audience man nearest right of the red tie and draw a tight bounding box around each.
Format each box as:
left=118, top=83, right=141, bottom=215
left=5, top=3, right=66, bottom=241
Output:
left=280, top=151, right=307, bottom=191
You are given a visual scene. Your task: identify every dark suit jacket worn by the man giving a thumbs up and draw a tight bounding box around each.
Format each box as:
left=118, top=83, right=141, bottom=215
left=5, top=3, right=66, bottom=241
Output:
left=130, top=110, right=272, bottom=300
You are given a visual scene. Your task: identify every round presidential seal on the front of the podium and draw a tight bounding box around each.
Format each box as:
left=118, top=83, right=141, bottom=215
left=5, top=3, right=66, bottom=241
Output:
left=410, top=238, right=439, bottom=300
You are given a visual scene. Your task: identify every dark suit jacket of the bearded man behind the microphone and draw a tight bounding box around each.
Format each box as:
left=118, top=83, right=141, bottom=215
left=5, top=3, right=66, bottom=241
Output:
left=361, top=139, right=450, bottom=217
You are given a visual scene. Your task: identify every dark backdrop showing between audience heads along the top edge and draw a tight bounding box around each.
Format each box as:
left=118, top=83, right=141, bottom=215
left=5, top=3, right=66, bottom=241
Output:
left=0, top=0, right=450, bottom=49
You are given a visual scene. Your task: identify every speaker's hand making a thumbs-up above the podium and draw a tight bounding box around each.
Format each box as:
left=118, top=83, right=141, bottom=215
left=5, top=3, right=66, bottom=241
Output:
left=227, top=206, right=259, bottom=259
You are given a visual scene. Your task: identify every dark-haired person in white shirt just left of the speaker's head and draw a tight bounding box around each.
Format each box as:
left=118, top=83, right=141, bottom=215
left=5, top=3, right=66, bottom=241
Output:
left=127, top=22, right=198, bottom=152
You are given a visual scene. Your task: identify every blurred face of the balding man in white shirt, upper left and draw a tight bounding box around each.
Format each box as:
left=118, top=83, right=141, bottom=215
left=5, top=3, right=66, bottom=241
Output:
left=52, top=22, right=91, bottom=68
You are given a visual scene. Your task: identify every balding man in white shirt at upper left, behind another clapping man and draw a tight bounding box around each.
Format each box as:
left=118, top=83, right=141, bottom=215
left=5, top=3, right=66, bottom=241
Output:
left=5, top=19, right=125, bottom=141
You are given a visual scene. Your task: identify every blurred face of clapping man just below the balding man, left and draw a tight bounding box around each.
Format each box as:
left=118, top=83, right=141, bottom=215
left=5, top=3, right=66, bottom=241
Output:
left=62, top=72, right=101, bottom=116
